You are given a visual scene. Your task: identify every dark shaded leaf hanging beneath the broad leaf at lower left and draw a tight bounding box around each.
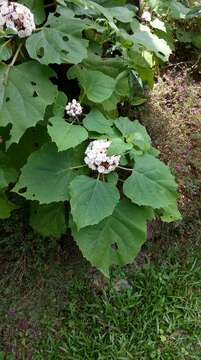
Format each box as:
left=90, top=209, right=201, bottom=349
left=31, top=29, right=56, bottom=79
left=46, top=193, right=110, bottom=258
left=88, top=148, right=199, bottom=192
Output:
left=29, top=202, right=66, bottom=238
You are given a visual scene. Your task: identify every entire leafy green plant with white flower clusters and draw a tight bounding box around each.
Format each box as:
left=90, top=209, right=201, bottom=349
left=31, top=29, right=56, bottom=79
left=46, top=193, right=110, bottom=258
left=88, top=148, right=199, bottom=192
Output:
left=0, top=0, right=180, bottom=276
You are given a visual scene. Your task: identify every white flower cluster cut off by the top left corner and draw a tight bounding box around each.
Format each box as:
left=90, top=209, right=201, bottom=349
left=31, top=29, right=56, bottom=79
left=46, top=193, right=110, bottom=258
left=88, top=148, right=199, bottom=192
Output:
left=0, top=0, right=35, bottom=38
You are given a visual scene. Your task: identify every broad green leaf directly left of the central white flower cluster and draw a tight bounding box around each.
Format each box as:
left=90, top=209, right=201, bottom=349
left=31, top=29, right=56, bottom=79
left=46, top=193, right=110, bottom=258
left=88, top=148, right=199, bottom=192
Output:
left=13, top=144, right=82, bottom=204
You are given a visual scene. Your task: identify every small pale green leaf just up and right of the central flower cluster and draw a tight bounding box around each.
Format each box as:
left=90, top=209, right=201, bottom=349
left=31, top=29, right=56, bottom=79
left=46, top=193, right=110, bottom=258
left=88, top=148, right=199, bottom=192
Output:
left=114, top=117, right=151, bottom=151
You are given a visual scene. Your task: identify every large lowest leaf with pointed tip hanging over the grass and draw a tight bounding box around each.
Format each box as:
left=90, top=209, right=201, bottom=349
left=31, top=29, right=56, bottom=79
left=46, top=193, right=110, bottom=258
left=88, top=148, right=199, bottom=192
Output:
left=72, top=200, right=149, bottom=276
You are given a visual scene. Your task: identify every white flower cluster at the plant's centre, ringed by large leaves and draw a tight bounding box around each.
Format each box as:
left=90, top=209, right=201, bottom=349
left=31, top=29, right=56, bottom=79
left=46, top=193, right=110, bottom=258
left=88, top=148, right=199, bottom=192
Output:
left=84, top=140, right=120, bottom=174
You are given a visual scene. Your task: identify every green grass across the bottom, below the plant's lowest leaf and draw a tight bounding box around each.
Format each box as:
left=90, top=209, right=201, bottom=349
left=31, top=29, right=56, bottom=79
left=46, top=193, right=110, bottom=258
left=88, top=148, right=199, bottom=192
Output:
left=0, top=239, right=201, bottom=360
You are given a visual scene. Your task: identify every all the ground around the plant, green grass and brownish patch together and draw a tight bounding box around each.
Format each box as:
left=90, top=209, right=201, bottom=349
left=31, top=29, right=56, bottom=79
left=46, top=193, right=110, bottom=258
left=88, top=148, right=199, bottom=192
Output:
left=0, top=69, right=201, bottom=360
